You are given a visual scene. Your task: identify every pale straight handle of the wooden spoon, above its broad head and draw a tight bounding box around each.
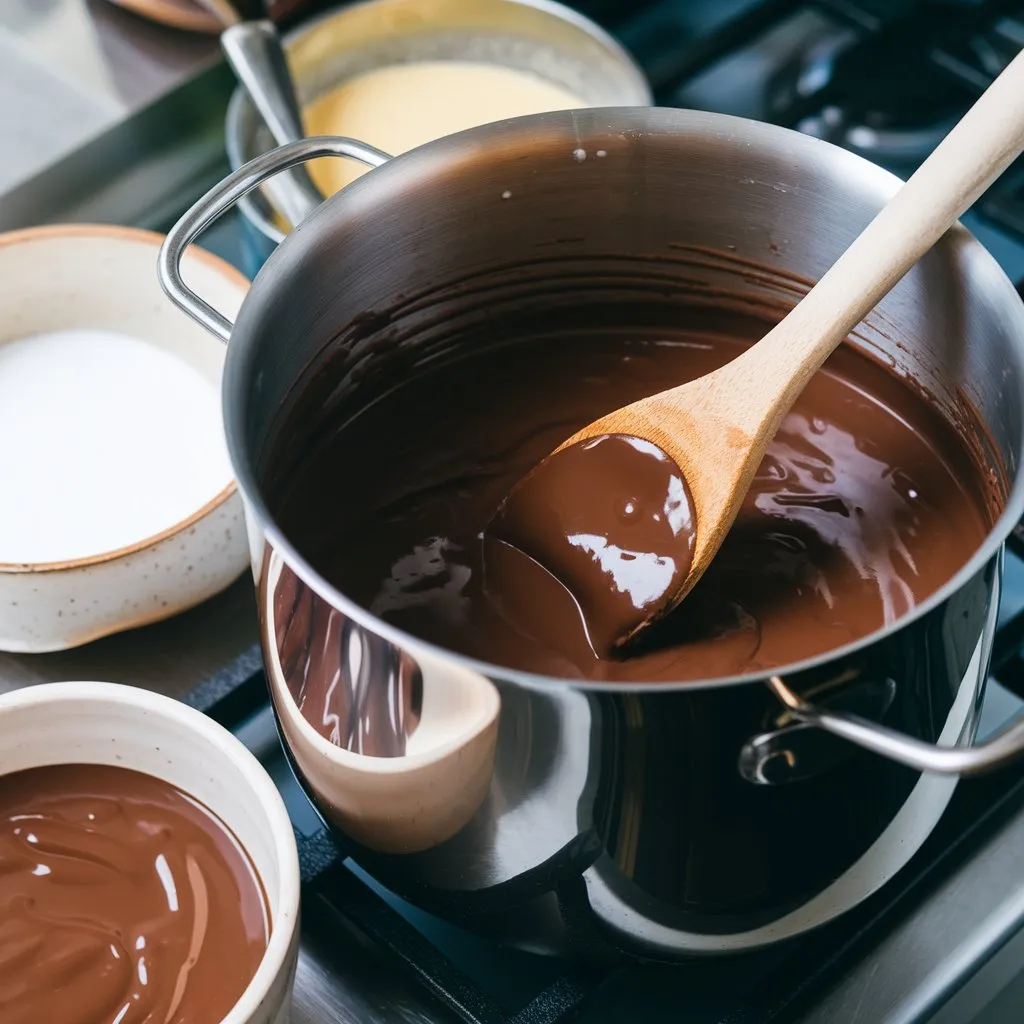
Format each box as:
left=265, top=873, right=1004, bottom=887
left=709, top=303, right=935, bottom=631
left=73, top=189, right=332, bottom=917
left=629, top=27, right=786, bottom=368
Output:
left=734, top=44, right=1024, bottom=434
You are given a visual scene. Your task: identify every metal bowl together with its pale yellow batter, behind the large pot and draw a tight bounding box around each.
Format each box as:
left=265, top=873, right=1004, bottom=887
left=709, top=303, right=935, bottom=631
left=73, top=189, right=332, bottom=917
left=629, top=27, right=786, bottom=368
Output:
left=226, top=0, right=651, bottom=255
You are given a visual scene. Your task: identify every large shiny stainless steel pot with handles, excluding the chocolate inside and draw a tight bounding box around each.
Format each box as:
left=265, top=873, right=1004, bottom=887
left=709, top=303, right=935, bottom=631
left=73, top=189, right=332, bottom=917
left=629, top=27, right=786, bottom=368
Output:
left=161, top=109, right=1024, bottom=957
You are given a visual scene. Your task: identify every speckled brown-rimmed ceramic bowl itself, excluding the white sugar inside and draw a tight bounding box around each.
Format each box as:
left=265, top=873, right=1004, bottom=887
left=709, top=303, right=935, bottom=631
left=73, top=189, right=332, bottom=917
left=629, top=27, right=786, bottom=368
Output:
left=0, top=225, right=249, bottom=652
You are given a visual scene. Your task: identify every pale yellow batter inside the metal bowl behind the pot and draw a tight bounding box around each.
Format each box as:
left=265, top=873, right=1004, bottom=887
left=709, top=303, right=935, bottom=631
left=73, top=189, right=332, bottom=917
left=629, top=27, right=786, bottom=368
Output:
left=303, top=60, right=586, bottom=196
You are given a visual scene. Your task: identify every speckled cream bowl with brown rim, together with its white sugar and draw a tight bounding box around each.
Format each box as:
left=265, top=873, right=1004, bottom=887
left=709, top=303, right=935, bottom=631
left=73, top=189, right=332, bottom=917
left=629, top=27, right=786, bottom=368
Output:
left=0, top=225, right=249, bottom=652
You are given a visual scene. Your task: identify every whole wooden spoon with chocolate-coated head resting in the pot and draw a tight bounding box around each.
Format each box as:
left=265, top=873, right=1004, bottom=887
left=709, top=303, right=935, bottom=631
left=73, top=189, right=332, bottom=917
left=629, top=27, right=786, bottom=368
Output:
left=488, top=53, right=1024, bottom=653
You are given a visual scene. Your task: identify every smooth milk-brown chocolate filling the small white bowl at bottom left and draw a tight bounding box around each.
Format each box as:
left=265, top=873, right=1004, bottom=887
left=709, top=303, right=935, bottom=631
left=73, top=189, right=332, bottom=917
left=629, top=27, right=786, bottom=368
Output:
left=0, top=765, right=269, bottom=1024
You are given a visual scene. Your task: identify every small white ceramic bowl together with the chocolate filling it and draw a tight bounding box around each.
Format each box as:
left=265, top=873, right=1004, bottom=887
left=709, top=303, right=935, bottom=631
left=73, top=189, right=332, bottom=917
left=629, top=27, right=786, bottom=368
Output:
left=0, top=682, right=299, bottom=1024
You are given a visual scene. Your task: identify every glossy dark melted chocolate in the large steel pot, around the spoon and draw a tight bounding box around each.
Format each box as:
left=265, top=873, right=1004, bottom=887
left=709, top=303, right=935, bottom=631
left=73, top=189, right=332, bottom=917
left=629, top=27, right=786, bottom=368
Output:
left=269, top=319, right=994, bottom=681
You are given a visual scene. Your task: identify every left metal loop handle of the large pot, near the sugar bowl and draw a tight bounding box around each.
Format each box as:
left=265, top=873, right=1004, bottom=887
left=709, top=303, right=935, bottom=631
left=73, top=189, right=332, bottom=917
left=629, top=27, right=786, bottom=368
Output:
left=157, top=135, right=391, bottom=343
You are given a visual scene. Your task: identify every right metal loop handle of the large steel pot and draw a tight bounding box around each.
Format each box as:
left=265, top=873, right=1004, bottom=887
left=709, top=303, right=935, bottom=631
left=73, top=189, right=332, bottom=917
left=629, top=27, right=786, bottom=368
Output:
left=740, top=676, right=1024, bottom=775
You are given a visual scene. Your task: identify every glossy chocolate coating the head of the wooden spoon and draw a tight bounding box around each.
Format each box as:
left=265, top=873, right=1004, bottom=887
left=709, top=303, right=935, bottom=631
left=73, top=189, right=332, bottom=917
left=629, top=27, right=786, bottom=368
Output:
left=487, top=434, right=695, bottom=656
